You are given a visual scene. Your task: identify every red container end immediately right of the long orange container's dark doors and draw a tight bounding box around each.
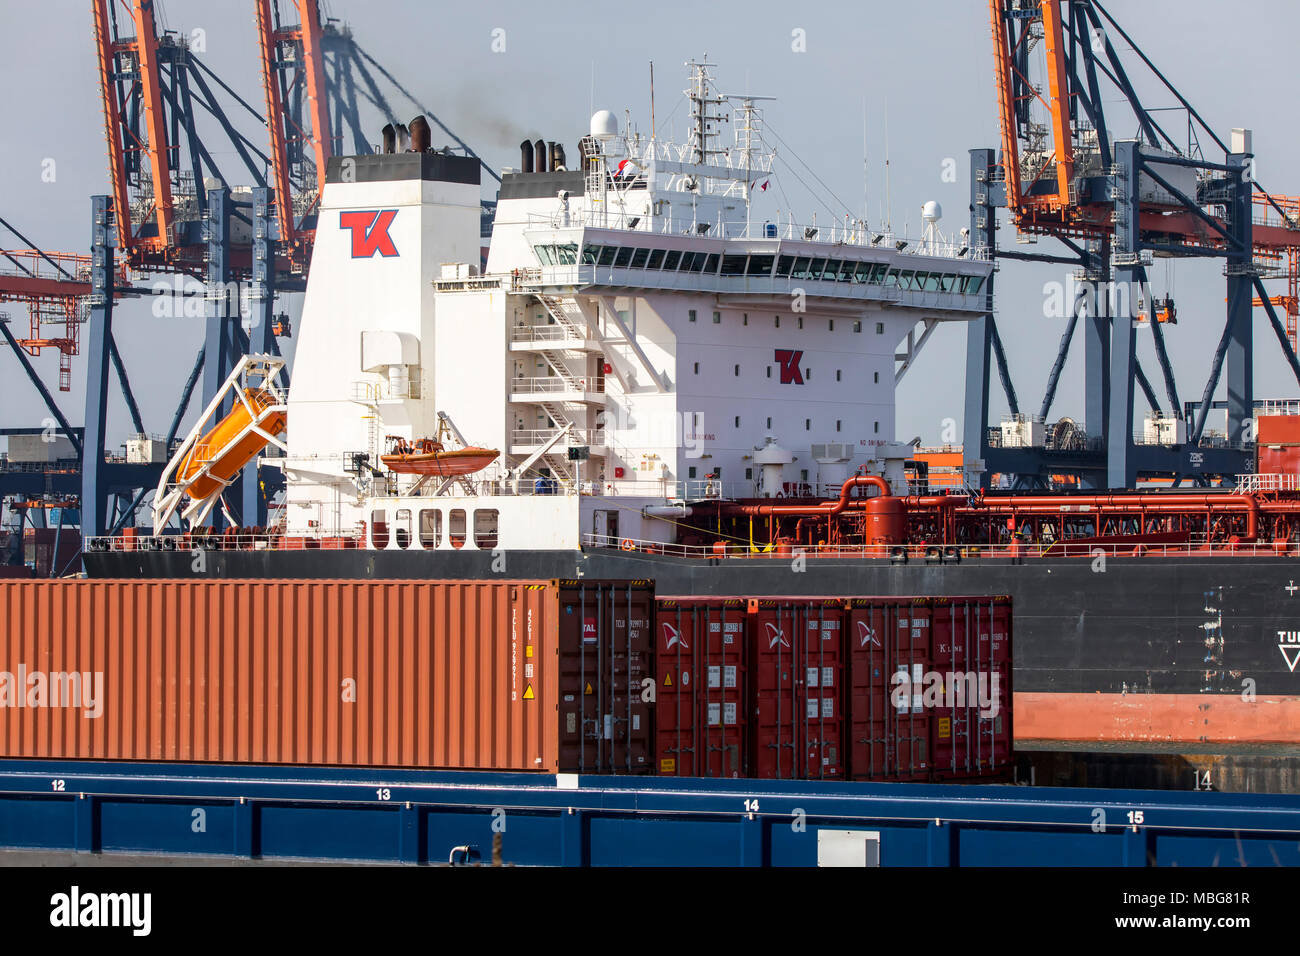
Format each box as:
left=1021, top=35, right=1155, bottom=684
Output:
left=655, top=598, right=749, bottom=777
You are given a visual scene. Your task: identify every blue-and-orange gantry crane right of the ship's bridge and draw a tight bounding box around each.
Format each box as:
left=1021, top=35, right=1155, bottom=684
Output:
left=965, top=0, right=1300, bottom=488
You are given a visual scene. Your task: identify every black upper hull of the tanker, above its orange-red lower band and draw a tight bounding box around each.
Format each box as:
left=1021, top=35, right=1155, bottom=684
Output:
left=85, top=549, right=1300, bottom=696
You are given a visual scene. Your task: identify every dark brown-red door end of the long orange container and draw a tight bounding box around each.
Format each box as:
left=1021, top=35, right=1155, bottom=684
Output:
left=559, top=583, right=654, bottom=774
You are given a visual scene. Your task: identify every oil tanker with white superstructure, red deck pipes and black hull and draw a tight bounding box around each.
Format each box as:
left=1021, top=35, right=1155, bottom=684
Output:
left=85, top=64, right=1300, bottom=785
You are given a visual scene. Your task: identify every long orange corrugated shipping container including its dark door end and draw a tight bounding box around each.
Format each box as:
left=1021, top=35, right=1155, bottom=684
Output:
left=0, top=580, right=653, bottom=773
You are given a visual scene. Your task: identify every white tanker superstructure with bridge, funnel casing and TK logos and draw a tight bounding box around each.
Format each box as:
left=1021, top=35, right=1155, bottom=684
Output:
left=271, top=64, right=992, bottom=549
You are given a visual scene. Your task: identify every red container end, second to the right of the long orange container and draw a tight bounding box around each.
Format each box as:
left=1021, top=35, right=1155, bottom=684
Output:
left=750, top=598, right=845, bottom=779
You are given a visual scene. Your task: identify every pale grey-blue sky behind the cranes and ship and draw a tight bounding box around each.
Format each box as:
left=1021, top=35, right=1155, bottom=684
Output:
left=0, top=0, right=1300, bottom=444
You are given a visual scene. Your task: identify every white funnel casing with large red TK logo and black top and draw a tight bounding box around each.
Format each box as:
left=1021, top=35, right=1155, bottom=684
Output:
left=286, top=153, right=481, bottom=532
